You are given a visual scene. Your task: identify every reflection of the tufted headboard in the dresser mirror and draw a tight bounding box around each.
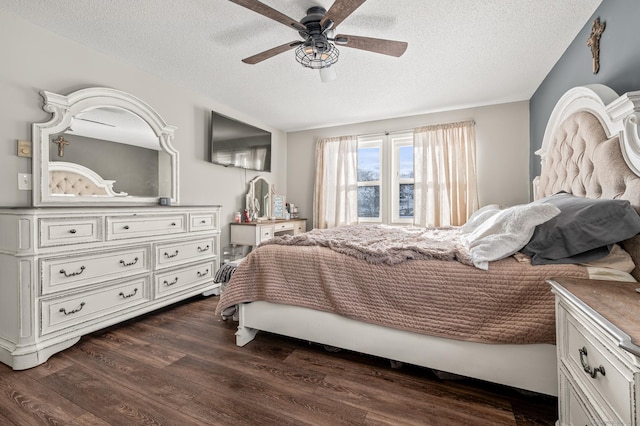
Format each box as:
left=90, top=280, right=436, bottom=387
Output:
left=48, top=161, right=127, bottom=197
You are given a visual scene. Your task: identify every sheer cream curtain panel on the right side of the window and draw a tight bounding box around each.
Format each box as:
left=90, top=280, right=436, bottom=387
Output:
left=413, top=121, right=478, bottom=227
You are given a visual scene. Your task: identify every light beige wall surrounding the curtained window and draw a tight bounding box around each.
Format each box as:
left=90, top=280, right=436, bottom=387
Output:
left=286, top=101, right=531, bottom=229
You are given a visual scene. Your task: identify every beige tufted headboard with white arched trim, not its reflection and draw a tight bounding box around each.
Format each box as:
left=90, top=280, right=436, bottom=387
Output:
left=533, top=85, right=640, bottom=281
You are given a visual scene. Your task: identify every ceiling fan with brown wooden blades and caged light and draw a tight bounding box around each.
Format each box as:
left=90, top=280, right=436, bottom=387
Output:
left=230, top=0, right=407, bottom=82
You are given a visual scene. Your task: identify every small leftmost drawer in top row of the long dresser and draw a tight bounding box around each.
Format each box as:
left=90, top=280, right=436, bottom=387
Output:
left=39, top=217, right=102, bottom=247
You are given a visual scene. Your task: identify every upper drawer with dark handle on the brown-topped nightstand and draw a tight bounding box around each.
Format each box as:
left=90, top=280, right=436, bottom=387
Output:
left=560, top=313, right=635, bottom=425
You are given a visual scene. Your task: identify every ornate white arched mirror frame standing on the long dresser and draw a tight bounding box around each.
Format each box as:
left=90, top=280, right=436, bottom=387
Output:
left=32, top=87, right=179, bottom=207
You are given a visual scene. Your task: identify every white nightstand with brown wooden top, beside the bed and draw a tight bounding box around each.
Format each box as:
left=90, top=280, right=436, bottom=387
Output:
left=549, top=278, right=640, bottom=426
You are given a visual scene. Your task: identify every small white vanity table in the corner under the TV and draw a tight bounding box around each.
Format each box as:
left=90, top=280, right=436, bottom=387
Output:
left=230, top=219, right=307, bottom=247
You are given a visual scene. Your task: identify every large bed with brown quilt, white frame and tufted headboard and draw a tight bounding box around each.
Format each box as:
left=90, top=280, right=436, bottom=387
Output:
left=217, top=85, right=640, bottom=395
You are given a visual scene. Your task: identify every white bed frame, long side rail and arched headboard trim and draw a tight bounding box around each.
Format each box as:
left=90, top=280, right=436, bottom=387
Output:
left=236, top=85, right=640, bottom=395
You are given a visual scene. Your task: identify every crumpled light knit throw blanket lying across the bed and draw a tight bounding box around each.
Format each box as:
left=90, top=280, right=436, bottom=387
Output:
left=261, top=225, right=473, bottom=265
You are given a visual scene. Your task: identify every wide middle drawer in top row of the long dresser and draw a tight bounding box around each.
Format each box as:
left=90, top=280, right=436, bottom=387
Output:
left=107, top=214, right=187, bottom=240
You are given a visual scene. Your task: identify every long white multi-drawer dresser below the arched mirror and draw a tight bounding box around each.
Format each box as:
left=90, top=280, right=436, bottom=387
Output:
left=0, top=206, right=220, bottom=370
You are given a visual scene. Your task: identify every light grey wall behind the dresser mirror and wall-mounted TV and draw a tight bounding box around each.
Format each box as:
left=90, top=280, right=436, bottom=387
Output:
left=0, top=11, right=287, bottom=244
